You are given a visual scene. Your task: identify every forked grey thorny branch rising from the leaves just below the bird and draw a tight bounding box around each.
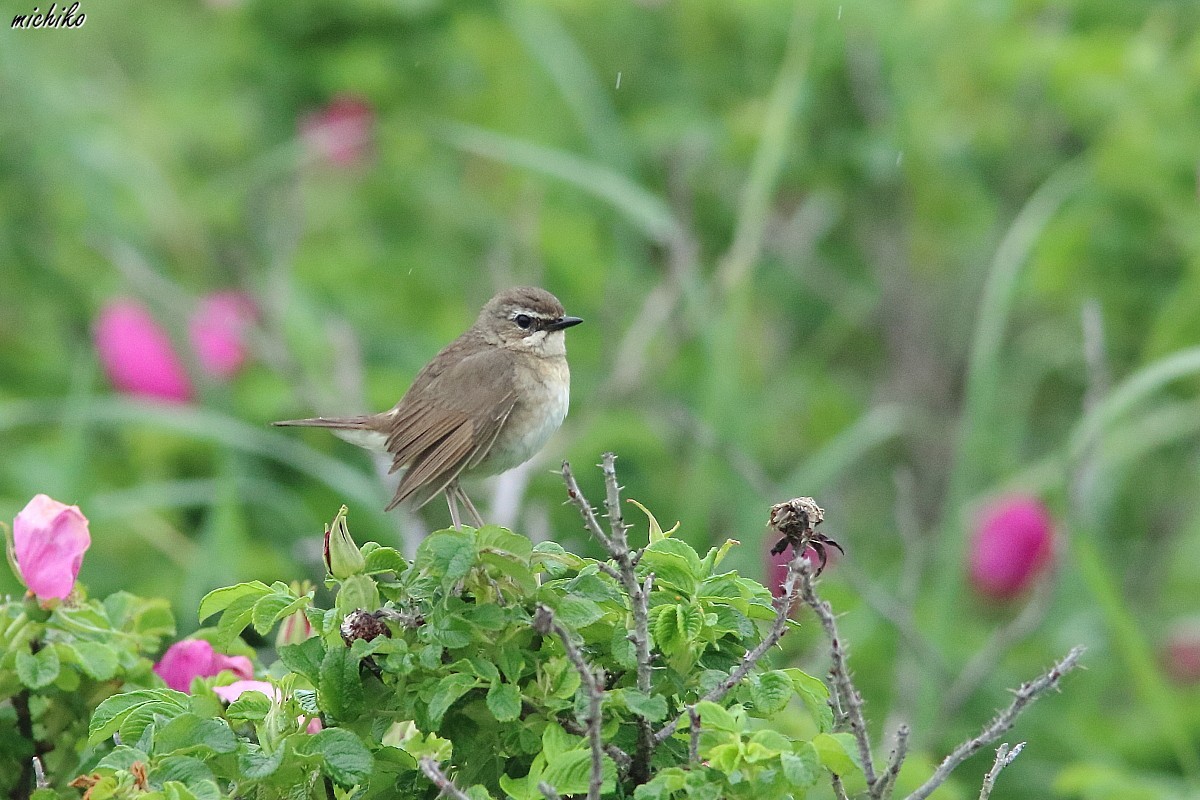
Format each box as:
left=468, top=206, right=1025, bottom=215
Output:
left=563, top=452, right=656, bottom=784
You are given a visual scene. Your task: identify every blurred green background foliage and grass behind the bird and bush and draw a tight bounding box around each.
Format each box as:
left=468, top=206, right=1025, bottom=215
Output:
left=0, top=0, right=1200, bottom=799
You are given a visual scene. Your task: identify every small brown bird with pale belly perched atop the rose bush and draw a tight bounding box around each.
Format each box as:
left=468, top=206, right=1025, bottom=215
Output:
left=275, top=287, right=583, bottom=528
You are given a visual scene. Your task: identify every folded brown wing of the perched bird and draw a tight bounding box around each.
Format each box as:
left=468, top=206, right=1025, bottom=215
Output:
left=388, top=348, right=516, bottom=510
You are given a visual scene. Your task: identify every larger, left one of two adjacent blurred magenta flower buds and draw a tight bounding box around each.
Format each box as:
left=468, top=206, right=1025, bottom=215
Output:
left=95, top=300, right=192, bottom=402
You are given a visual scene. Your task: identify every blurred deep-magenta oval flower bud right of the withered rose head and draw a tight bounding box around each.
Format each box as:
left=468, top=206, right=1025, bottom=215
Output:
left=970, top=497, right=1055, bottom=600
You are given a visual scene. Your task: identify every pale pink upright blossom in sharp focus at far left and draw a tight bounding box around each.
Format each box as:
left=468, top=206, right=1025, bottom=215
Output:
left=12, top=494, right=91, bottom=600
